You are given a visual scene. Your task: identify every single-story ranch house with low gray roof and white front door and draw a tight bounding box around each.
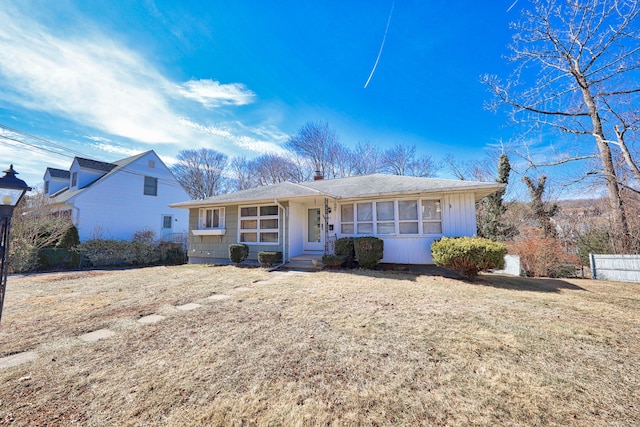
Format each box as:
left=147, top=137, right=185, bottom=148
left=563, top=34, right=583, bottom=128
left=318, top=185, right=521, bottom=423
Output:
left=171, top=174, right=504, bottom=264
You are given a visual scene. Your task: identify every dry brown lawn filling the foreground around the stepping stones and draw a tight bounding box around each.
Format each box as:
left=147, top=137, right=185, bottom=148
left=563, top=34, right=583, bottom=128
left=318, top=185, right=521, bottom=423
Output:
left=0, top=266, right=640, bottom=426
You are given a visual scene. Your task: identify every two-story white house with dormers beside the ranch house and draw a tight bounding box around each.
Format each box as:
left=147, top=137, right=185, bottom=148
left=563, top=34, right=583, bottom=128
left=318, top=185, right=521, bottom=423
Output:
left=44, top=150, right=189, bottom=241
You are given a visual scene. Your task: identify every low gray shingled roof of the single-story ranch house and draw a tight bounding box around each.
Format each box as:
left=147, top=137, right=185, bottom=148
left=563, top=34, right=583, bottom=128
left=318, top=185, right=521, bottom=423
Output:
left=170, top=174, right=504, bottom=208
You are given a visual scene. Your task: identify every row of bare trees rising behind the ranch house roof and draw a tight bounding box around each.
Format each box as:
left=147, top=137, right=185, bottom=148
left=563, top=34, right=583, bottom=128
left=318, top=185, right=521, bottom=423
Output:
left=171, top=122, right=442, bottom=199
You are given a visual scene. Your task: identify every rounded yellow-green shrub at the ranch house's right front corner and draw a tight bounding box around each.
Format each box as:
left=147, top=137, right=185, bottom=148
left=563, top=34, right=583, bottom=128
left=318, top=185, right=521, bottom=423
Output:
left=431, top=237, right=507, bottom=280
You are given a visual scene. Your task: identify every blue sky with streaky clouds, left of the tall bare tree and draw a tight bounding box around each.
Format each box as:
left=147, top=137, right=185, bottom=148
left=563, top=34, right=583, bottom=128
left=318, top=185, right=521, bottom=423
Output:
left=0, top=0, right=519, bottom=191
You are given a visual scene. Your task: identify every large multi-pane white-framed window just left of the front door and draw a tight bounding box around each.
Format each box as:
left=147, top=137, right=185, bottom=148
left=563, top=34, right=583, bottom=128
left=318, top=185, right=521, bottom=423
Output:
left=239, top=205, right=280, bottom=244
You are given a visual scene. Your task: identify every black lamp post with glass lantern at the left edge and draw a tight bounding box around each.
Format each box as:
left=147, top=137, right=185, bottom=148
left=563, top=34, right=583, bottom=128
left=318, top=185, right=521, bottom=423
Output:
left=0, top=165, right=31, bottom=321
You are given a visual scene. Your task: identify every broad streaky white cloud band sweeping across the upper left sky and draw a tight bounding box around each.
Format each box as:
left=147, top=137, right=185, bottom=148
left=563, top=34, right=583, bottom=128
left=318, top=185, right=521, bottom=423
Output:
left=0, top=7, right=277, bottom=154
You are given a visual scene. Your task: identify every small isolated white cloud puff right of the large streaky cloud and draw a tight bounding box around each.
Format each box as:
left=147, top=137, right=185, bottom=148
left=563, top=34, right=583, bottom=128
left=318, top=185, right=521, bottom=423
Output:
left=178, top=79, right=255, bottom=108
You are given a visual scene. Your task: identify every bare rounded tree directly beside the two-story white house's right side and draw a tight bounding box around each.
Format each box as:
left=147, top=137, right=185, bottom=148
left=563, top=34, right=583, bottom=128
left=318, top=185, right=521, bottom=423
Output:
left=171, top=148, right=227, bottom=199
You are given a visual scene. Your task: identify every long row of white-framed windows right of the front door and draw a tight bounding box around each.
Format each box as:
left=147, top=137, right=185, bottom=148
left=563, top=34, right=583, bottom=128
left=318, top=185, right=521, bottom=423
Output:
left=340, top=199, right=442, bottom=236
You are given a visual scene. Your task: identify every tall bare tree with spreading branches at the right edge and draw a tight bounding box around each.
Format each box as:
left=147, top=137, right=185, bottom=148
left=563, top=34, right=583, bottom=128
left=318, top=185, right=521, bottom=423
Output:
left=483, top=0, right=640, bottom=251
